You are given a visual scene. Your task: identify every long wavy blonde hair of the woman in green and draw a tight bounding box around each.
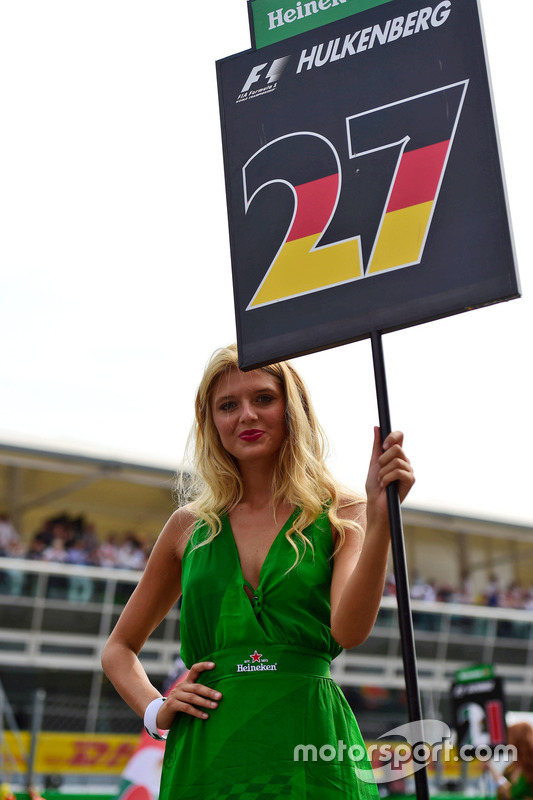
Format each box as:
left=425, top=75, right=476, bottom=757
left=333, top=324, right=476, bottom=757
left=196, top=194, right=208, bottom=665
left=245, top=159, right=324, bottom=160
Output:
left=182, top=345, right=364, bottom=565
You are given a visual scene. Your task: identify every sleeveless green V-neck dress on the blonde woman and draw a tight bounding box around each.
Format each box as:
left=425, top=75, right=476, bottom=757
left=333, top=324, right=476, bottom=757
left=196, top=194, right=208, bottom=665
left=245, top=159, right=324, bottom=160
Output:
left=160, top=511, right=378, bottom=800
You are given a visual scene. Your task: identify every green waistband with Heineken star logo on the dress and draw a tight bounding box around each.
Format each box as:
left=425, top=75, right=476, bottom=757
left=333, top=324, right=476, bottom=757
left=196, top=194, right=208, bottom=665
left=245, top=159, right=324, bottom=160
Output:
left=196, top=645, right=331, bottom=686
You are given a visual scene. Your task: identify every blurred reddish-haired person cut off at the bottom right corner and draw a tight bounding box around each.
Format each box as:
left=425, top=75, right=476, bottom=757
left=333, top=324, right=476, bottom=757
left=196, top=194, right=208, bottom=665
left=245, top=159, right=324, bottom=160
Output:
left=484, top=722, right=533, bottom=800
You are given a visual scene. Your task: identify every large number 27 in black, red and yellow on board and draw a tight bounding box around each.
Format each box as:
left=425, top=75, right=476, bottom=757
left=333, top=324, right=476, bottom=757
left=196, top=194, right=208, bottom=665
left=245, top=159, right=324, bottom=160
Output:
left=243, top=81, right=468, bottom=310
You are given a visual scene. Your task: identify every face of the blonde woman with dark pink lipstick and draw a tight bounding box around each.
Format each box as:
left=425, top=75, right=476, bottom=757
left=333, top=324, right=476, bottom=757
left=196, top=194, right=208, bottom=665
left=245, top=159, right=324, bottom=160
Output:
left=211, top=367, right=287, bottom=462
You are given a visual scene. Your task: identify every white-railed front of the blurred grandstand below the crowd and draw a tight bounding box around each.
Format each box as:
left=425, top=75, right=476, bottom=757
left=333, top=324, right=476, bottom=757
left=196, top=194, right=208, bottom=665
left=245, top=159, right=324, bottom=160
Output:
left=0, top=558, right=533, bottom=730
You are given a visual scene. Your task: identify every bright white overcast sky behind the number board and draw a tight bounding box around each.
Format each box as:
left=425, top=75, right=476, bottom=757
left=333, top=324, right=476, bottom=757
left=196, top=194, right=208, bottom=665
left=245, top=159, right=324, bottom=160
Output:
left=0, top=0, right=533, bottom=526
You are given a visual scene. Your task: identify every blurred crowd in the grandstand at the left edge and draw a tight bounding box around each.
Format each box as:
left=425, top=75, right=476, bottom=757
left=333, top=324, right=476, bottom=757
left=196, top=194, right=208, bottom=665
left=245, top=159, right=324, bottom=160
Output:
left=0, top=514, right=153, bottom=570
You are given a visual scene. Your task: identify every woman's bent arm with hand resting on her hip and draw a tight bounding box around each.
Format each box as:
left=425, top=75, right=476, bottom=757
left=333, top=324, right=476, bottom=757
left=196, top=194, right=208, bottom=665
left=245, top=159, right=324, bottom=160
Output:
left=102, top=507, right=219, bottom=728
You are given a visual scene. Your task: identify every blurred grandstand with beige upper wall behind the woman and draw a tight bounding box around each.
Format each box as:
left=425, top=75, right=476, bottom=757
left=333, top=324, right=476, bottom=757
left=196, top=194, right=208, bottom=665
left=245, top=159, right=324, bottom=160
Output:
left=0, top=445, right=533, bottom=788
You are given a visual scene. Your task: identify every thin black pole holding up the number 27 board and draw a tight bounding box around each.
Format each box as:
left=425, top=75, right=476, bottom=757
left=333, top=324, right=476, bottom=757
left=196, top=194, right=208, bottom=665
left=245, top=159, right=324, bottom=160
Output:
left=370, top=331, right=429, bottom=800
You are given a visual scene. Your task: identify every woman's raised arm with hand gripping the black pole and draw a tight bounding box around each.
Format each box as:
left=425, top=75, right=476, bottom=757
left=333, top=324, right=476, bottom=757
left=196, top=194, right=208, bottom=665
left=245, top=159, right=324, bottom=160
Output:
left=331, top=428, right=415, bottom=648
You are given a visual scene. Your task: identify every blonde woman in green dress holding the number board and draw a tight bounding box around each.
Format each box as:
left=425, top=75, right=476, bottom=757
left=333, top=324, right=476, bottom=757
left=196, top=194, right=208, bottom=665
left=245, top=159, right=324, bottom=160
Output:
left=102, top=346, right=414, bottom=800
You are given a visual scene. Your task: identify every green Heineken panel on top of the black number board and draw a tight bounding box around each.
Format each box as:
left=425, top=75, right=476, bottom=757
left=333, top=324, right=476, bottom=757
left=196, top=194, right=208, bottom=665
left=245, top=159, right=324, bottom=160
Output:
left=251, top=0, right=391, bottom=48
